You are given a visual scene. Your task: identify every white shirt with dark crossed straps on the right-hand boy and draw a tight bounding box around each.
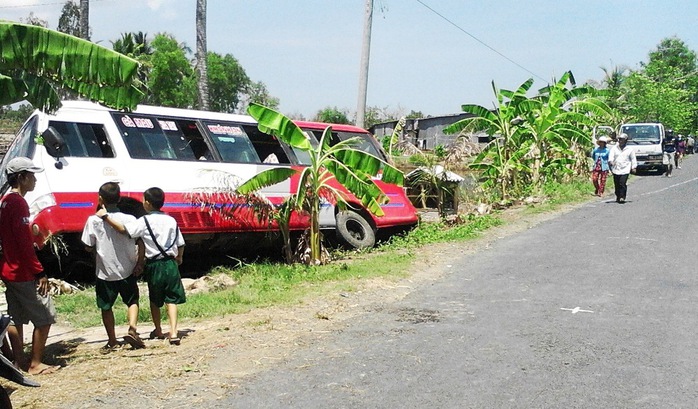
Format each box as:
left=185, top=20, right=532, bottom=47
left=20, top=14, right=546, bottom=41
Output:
left=124, top=212, right=184, bottom=259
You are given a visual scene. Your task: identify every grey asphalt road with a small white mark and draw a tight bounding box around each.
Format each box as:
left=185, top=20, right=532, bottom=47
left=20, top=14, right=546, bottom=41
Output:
left=223, top=156, right=698, bottom=408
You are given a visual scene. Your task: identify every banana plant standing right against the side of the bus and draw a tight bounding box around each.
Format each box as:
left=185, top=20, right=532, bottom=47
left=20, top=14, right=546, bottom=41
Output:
left=237, top=103, right=404, bottom=264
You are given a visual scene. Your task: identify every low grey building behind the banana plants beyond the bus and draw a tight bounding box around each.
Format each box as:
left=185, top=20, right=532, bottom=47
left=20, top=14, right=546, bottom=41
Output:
left=369, top=113, right=489, bottom=150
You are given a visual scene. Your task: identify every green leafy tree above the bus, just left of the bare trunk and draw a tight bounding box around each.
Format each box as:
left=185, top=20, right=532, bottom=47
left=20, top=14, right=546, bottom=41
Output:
left=147, top=34, right=196, bottom=108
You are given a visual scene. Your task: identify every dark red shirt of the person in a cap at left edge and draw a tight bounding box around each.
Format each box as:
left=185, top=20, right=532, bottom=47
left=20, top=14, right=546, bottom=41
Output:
left=0, top=192, right=44, bottom=282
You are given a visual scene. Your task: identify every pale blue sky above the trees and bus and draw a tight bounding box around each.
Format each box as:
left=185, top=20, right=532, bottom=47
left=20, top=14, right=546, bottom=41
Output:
left=0, top=0, right=698, bottom=118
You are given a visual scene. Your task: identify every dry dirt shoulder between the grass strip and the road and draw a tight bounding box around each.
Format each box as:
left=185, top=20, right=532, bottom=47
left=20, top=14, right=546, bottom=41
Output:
left=0, top=202, right=569, bottom=408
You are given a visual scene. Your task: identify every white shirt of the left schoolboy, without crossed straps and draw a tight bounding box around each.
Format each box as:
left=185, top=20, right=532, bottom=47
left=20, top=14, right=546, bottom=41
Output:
left=81, top=212, right=138, bottom=281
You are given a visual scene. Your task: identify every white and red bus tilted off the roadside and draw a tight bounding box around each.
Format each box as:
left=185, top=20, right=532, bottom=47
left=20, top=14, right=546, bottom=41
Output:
left=0, top=101, right=417, bottom=276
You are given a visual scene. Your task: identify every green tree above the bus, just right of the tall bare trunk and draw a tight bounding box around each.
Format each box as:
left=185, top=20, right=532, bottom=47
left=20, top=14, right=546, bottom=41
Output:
left=208, top=52, right=250, bottom=112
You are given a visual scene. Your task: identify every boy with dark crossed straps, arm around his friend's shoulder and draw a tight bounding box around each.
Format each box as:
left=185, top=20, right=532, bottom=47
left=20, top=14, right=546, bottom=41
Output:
left=97, top=187, right=186, bottom=345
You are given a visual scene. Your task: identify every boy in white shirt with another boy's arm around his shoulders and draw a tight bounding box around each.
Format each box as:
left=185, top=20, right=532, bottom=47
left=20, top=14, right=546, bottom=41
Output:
left=82, top=182, right=145, bottom=351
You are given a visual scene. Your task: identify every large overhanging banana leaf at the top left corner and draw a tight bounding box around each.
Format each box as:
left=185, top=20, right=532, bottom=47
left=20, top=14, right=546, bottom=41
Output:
left=0, top=21, right=144, bottom=112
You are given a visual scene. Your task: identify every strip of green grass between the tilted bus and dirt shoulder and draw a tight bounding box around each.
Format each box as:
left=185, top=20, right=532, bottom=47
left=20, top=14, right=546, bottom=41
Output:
left=55, top=176, right=591, bottom=328
